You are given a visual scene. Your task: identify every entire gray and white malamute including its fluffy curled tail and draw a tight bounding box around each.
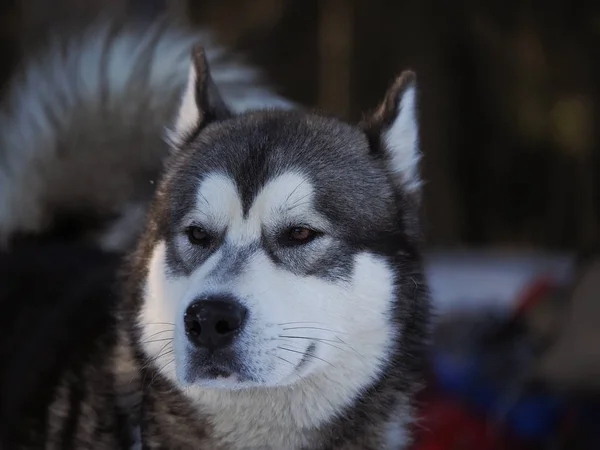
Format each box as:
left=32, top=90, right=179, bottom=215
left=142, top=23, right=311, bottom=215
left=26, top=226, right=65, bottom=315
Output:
left=0, top=17, right=429, bottom=450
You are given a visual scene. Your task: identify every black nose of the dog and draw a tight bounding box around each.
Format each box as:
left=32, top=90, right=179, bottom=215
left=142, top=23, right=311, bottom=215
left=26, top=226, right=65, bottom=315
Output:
left=183, top=296, right=247, bottom=350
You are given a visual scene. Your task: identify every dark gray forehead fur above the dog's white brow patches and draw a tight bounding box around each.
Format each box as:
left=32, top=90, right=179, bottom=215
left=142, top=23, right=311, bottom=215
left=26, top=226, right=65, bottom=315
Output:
left=166, top=111, right=396, bottom=234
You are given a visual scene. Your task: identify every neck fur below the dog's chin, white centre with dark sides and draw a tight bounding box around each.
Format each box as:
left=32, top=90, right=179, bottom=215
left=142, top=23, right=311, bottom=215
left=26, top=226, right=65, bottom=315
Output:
left=133, top=348, right=412, bottom=450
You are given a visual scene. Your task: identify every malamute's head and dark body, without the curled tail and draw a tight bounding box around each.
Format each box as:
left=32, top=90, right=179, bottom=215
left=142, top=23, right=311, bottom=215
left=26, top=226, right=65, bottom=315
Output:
left=0, top=19, right=429, bottom=450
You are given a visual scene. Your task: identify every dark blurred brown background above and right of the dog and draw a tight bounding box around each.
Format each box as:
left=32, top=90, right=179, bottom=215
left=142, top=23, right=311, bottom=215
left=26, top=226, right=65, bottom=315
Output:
left=0, top=0, right=600, bottom=250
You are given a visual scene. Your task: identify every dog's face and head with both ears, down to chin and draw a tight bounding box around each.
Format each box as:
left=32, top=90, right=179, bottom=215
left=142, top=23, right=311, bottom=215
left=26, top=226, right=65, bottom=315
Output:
left=140, top=46, right=419, bottom=389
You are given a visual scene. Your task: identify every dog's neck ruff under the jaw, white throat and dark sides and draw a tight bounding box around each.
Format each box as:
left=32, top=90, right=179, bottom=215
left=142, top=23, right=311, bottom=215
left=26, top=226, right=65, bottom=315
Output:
left=115, top=310, right=412, bottom=450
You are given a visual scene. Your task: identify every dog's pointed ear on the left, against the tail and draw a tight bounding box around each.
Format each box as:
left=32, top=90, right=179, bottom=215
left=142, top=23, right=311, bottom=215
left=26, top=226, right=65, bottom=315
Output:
left=168, top=44, right=232, bottom=146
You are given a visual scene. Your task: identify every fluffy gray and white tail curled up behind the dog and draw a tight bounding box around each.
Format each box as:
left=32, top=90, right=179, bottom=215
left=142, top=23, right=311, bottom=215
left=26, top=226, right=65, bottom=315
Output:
left=0, top=21, right=291, bottom=250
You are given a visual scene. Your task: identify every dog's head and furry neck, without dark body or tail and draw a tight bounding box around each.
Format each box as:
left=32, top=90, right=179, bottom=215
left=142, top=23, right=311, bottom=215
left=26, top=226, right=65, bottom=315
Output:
left=130, top=49, right=429, bottom=450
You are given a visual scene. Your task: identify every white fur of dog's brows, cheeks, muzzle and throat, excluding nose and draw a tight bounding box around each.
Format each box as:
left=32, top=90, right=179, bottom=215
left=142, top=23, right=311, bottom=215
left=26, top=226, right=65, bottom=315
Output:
left=140, top=172, right=401, bottom=449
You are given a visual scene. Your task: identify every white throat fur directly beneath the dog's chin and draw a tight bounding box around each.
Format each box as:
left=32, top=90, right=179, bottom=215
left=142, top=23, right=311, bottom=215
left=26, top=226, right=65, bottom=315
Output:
left=178, top=342, right=400, bottom=450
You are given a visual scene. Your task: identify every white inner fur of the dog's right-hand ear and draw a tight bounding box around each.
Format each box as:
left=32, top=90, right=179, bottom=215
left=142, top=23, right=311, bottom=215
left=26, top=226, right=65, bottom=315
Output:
left=383, top=86, right=421, bottom=192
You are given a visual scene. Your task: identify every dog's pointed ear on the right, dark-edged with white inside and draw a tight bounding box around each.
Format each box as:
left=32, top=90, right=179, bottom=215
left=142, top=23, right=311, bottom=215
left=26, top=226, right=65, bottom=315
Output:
left=363, top=71, right=421, bottom=197
